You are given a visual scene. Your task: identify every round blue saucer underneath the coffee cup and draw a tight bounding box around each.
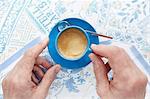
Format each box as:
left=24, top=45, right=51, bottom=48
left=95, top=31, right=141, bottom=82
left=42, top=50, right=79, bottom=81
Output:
left=48, top=18, right=99, bottom=69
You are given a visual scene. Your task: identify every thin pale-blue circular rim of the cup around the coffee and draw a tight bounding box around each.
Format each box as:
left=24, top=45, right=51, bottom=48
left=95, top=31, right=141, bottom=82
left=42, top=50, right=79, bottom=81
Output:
left=55, top=25, right=90, bottom=61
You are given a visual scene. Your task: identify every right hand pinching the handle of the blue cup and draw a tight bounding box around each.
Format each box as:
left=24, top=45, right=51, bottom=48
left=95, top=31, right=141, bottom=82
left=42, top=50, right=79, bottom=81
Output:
left=89, top=45, right=147, bottom=99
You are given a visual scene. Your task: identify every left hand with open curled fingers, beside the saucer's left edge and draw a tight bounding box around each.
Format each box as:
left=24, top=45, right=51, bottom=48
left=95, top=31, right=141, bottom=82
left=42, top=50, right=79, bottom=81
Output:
left=2, top=39, right=60, bottom=99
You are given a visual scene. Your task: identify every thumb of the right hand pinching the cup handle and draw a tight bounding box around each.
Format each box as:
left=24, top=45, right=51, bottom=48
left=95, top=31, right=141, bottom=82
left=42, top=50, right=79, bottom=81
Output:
left=89, top=53, right=109, bottom=90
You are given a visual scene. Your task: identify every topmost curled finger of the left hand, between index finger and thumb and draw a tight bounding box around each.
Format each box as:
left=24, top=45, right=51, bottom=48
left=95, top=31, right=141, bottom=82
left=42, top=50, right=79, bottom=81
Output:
left=35, top=56, right=52, bottom=69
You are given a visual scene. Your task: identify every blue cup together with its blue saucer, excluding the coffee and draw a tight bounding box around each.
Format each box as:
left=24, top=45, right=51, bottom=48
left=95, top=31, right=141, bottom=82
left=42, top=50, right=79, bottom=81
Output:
left=48, top=18, right=99, bottom=69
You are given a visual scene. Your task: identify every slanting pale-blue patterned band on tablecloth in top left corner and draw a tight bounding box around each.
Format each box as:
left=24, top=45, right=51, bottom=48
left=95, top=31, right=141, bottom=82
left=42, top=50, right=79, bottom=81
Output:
left=0, top=0, right=27, bottom=53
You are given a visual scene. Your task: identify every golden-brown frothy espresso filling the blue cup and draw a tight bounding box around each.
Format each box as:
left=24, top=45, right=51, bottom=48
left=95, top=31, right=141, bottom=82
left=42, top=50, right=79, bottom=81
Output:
left=57, top=28, right=87, bottom=59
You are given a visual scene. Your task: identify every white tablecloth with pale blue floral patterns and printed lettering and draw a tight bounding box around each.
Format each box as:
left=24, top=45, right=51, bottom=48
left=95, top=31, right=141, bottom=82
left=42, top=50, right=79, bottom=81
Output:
left=0, top=0, right=150, bottom=99
